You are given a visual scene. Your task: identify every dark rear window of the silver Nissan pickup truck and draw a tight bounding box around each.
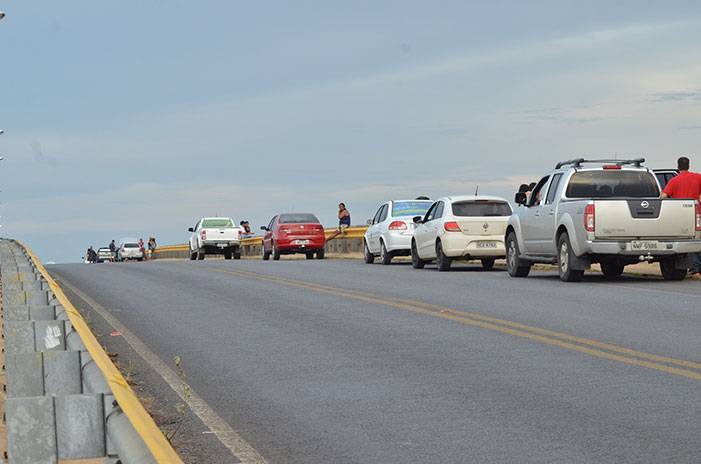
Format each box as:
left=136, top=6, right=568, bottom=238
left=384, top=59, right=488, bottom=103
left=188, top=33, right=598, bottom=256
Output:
left=566, top=169, right=660, bottom=198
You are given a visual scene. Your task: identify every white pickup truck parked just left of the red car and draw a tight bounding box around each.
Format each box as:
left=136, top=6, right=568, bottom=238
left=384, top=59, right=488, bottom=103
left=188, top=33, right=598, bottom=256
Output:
left=187, top=217, right=242, bottom=260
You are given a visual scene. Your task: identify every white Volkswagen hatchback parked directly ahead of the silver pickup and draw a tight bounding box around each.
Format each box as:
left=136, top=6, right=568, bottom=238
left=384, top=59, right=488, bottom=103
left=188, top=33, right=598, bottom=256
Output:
left=411, top=195, right=511, bottom=271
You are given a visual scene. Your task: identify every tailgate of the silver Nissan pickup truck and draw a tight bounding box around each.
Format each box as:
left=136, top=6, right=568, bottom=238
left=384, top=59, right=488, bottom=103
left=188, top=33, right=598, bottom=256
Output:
left=594, top=198, right=696, bottom=239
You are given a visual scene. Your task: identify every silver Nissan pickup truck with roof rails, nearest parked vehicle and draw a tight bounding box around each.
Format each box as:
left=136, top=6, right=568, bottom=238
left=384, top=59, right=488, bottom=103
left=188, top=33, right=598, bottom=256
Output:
left=505, top=159, right=701, bottom=282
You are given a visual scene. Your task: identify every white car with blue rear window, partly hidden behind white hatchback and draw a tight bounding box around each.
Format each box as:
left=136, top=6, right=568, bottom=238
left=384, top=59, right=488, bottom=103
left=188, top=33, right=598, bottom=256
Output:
left=364, top=200, right=433, bottom=264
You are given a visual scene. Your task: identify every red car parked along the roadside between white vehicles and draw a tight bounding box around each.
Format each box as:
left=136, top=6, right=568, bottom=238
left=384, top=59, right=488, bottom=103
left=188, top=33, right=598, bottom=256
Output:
left=261, top=213, right=326, bottom=261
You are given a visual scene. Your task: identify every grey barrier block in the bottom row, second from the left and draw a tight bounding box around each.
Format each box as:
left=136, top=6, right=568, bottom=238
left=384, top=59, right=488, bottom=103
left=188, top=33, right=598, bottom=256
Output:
left=56, top=395, right=106, bottom=459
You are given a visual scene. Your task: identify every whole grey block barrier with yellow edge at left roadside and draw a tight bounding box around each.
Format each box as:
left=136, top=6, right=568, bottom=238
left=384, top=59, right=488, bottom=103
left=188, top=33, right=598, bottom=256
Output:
left=0, top=239, right=182, bottom=464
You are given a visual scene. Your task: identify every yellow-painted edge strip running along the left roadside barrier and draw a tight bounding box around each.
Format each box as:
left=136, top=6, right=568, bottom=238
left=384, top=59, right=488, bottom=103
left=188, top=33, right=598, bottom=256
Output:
left=16, top=241, right=182, bottom=464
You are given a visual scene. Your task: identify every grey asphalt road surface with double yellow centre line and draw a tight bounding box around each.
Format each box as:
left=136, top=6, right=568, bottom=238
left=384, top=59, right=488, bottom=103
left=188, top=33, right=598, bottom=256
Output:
left=49, top=259, right=701, bottom=464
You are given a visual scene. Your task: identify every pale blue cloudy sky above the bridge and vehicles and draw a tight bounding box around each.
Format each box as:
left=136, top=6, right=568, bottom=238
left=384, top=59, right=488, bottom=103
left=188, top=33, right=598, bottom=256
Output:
left=0, top=0, right=701, bottom=262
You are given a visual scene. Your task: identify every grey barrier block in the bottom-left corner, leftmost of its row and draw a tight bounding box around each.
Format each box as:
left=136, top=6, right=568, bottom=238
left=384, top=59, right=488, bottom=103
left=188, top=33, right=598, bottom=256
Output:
left=5, top=396, right=58, bottom=464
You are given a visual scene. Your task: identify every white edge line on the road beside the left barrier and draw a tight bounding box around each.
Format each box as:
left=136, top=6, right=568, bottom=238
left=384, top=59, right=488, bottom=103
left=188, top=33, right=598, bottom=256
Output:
left=56, top=279, right=267, bottom=464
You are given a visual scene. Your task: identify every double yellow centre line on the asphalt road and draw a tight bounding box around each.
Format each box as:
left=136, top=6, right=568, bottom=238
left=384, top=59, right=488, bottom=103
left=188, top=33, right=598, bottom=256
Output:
left=210, top=269, right=701, bottom=380
